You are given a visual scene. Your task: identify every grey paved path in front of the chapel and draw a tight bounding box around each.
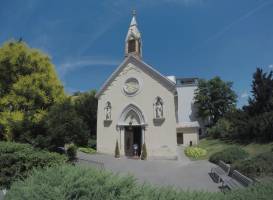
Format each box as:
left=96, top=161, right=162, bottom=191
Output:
left=78, top=152, right=220, bottom=191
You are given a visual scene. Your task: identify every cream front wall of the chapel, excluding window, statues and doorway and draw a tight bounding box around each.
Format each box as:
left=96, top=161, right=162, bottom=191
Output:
left=97, top=60, right=176, bottom=158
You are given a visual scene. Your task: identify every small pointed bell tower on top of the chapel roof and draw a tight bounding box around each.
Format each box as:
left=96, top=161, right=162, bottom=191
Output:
left=125, top=10, right=142, bottom=58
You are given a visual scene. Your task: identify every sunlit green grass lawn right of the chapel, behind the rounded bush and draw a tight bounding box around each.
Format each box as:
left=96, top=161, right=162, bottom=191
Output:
left=193, top=138, right=273, bottom=159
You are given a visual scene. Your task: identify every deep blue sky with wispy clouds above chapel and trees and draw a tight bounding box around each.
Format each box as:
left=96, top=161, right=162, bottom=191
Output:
left=0, top=0, right=273, bottom=107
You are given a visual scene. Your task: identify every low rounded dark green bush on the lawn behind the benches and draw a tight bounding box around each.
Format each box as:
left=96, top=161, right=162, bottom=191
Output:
left=209, top=146, right=248, bottom=164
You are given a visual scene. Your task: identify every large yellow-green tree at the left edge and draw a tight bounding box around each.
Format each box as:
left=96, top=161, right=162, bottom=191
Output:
left=0, top=41, right=65, bottom=143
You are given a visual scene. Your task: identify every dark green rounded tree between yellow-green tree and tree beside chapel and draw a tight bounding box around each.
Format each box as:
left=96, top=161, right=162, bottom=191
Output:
left=46, top=97, right=90, bottom=149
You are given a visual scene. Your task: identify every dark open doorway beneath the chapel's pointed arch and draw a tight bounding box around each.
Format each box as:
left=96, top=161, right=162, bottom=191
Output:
left=124, top=126, right=142, bottom=158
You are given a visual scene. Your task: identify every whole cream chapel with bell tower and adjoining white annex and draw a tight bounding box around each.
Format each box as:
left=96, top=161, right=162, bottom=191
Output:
left=96, top=14, right=202, bottom=159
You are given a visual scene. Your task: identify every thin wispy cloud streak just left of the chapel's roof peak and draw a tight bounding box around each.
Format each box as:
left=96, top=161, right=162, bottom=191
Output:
left=57, top=57, right=120, bottom=78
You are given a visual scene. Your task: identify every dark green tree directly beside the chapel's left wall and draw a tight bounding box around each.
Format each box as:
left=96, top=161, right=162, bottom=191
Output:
left=73, top=90, right=98, bottom=137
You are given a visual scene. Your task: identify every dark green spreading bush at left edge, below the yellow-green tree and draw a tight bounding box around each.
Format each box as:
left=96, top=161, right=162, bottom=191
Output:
left=0, top=142, right=66, bottom=188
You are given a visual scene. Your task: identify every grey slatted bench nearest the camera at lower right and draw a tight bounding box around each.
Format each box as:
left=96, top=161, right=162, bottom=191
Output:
left=223, top=170, right=254, bottom=190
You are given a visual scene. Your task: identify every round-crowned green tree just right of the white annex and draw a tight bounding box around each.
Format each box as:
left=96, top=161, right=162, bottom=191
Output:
left=194, top=77, right=237, bottom=126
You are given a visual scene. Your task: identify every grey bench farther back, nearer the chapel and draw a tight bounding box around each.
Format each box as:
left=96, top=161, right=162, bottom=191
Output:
left=211, top=160, right=230, bottom=183
